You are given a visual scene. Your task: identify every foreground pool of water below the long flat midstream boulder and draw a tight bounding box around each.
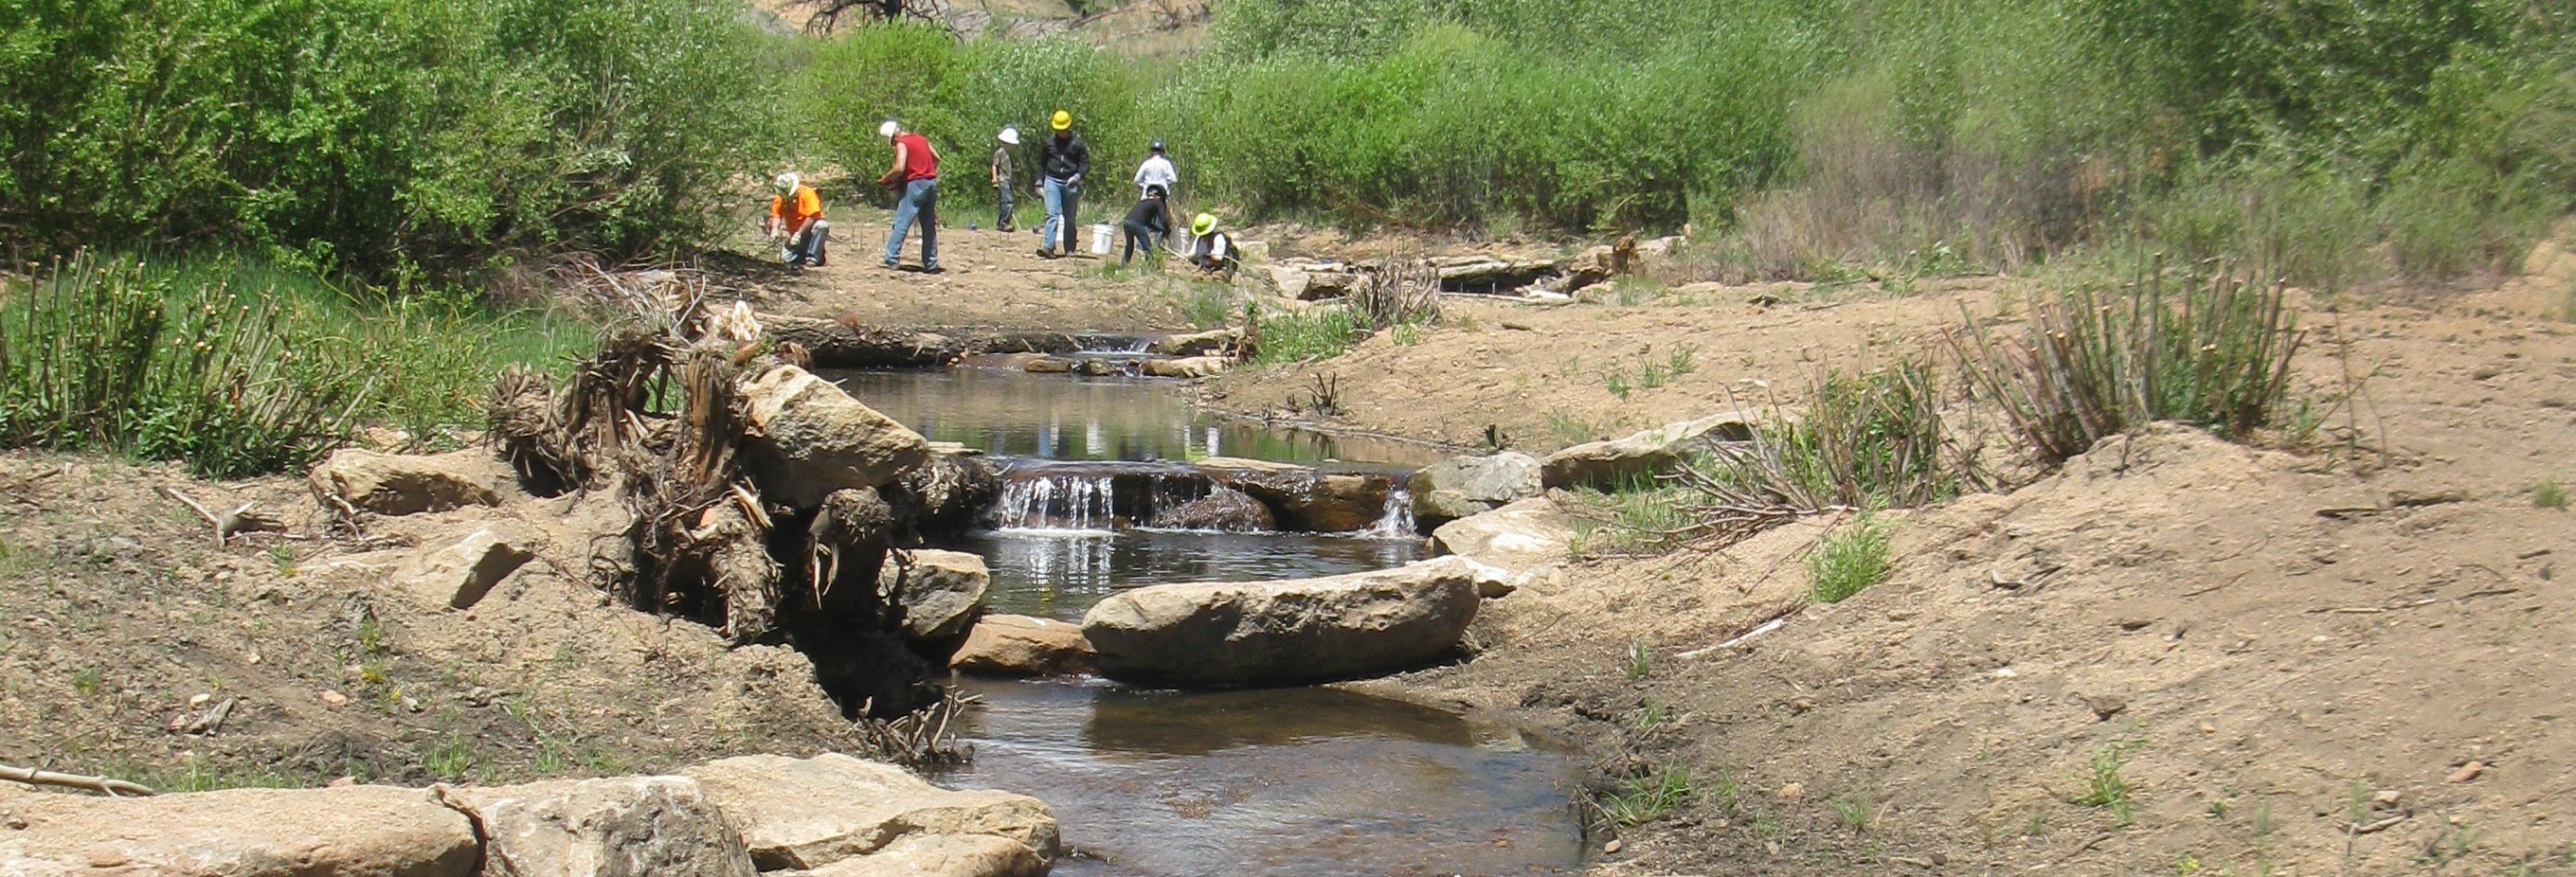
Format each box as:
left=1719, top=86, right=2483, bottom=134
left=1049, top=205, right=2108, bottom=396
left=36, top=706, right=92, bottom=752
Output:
left=940, top=682, right=1581, bottom=877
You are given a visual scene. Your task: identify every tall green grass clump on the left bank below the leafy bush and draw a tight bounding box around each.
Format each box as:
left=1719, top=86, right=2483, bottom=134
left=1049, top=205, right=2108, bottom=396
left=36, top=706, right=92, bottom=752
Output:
left=0, top=255, right=590, bottom=478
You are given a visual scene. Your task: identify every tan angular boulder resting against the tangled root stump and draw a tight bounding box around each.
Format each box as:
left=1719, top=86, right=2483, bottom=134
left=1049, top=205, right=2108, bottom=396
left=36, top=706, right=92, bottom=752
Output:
left=742, top=366, right=930, bottom=510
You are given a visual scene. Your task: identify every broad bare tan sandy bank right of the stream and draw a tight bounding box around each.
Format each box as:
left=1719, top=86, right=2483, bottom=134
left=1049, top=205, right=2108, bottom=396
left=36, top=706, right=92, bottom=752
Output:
left=1326, top=277, right=2576, bottom=874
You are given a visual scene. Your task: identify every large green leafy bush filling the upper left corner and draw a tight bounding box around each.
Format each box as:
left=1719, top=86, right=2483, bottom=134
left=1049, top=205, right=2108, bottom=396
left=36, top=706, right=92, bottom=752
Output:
left=0, top=0, right=775, bottom=277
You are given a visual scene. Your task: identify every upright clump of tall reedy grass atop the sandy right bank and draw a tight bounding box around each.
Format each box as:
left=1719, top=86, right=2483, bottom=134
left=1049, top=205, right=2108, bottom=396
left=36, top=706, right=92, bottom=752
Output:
left=1950, top=260, right=2306, bottom=466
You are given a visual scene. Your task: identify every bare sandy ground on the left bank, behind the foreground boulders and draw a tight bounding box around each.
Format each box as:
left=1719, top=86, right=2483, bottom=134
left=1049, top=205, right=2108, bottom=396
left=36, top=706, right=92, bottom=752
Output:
left=0, top=453, right=857, bottom=784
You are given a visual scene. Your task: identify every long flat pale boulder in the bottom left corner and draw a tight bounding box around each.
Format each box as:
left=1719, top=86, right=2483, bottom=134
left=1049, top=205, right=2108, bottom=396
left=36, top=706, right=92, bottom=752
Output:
left=0, top=784, right=481, bottom=877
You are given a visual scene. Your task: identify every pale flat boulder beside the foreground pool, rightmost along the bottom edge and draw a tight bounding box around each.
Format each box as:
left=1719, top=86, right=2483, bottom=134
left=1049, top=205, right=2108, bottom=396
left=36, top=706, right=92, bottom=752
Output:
left=683, top=754, right=1056, bottom=872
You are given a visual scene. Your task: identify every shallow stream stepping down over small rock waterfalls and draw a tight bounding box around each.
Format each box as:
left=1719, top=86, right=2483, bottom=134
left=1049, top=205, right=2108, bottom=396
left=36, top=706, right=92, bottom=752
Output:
left=830, top=352, right=1581, bottom=877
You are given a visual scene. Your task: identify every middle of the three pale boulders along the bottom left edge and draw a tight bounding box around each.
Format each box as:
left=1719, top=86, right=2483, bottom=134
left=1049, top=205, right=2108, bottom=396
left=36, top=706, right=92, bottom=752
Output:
left=438, top=777, right=757, bottom=877
